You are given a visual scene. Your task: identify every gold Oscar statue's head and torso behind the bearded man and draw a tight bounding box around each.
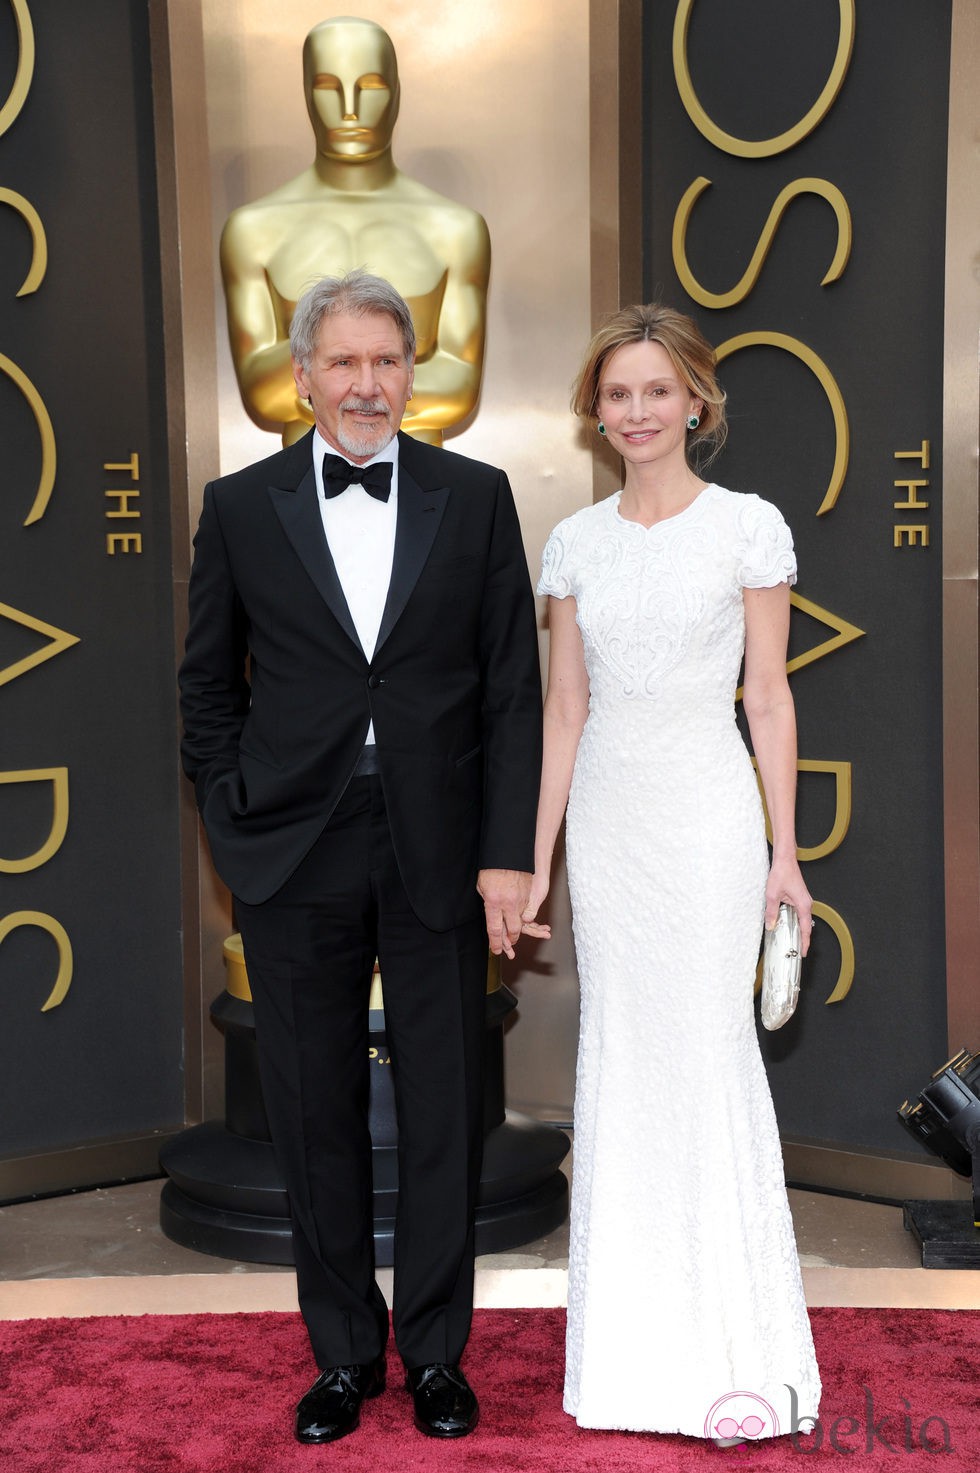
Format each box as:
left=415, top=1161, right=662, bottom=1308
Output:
left=221, top=16, right=489, bottom=445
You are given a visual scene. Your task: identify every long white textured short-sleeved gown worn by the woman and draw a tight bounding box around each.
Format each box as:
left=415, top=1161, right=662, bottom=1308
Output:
left=538, top=485, right=819, bottom=1436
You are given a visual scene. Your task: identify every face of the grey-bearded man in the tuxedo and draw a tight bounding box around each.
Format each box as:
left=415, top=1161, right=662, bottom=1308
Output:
left=293, top=312, right=414, bottom=464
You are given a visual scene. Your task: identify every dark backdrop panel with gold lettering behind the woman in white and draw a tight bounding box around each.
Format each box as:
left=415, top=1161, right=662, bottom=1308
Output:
left=643, top=0, right=949, bottom=1150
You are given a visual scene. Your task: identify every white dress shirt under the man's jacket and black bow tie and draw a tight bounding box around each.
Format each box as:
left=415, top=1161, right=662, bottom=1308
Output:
left=312, top=430, right=398, bottom=745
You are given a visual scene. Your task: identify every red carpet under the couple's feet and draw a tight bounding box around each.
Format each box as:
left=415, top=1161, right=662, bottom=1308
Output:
left=0, top=1309, right=980, bottom=1473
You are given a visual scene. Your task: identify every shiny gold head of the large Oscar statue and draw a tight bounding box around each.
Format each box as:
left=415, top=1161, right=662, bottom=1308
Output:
left=304, top=15, right=399, bottom=164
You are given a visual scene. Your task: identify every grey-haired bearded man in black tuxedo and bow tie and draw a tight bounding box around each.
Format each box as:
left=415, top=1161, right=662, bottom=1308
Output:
left=181, top=271, right=541, bottom=1442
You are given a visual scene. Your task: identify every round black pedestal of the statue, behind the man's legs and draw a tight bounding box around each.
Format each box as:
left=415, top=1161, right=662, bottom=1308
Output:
left=161, top=947, right=569, bottom=1265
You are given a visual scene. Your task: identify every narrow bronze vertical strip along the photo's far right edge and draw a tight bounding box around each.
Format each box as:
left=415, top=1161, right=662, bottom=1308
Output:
left=943, top=0, right=980, bottom=1053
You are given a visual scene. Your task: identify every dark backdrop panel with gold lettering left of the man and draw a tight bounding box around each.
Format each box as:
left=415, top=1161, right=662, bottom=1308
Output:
left=0, top=0, right=183, bottom=1158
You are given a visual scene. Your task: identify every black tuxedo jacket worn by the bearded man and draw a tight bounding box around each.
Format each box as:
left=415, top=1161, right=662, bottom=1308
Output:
left=180, top=432, right=541, bottom=931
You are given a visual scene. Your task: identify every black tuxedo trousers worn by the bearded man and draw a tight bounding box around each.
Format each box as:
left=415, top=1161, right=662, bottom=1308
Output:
left=236, top=776, right=486, bottom=1368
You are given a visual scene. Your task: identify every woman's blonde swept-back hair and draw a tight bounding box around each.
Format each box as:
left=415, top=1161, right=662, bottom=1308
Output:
left=572, top=302, right=728, bottom=464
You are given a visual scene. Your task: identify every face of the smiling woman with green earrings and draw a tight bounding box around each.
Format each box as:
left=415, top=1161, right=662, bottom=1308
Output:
left=597, top=342, right=703, bottom=464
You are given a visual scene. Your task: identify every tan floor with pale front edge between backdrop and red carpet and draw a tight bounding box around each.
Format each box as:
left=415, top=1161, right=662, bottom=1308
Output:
left=0, top=1148, right=980, bottom=1313
